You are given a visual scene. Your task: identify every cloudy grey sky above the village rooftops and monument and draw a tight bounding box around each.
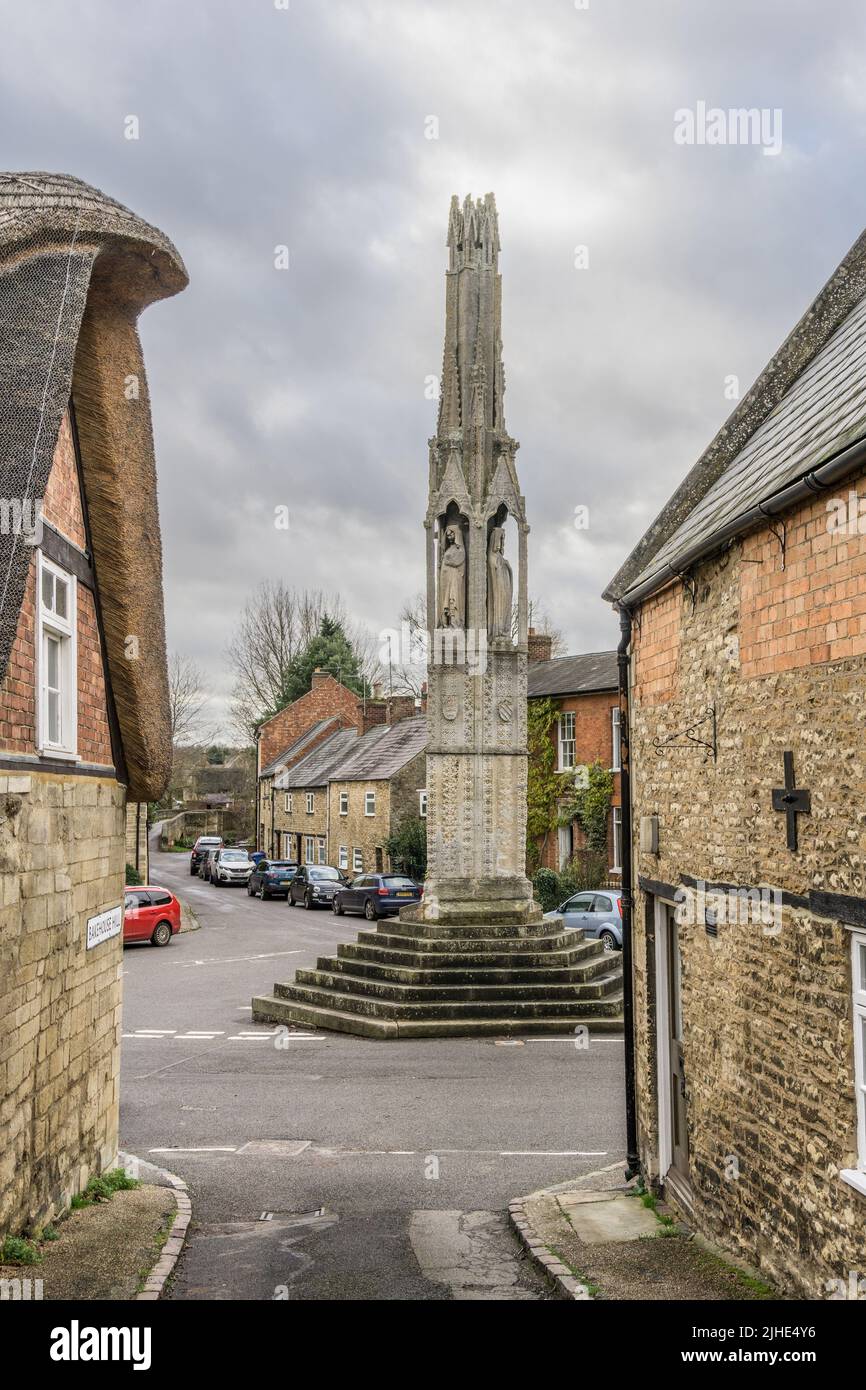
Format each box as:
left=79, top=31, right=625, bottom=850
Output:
left=0, top=0, right=866, bottom=739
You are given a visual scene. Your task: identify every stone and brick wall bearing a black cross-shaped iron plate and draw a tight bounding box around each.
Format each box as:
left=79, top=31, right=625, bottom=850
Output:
left=631, top=475, right=866, bottom=1297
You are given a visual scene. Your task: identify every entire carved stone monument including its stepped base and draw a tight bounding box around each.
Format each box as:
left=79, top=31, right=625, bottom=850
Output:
left=253, top=201, right=623, bottom=1040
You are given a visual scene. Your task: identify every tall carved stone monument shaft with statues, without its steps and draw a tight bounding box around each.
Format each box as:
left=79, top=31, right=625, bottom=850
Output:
left=417, top=193, right=539, bottom=922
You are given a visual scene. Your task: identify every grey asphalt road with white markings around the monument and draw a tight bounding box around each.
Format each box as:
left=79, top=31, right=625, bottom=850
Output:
left=121, top=853, right=624, bottom=1300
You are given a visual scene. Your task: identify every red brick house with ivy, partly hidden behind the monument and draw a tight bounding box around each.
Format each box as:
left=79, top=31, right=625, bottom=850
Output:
left=527, top=632, right=623, bottom=878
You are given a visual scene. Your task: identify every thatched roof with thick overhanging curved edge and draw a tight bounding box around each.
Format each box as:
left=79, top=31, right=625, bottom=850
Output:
left=0, top=172, right=188, bottom=801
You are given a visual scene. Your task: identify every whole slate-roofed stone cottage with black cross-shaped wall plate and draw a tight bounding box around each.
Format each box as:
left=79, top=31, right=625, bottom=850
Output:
left=606, top=225, right=866, bottom=1298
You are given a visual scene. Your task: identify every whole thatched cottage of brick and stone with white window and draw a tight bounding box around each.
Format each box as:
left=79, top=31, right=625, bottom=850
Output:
left=0, top=174, right=186, bottom=1233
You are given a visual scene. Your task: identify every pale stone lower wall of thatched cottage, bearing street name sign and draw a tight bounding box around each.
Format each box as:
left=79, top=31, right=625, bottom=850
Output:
left=0, top=771, right=125, bottom=1233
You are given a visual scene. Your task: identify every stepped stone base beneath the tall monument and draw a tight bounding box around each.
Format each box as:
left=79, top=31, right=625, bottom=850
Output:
left=253, top=904, right=623, bottom=1040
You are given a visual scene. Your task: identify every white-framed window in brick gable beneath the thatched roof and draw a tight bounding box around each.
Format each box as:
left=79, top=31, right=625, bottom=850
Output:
left=38, top=552, right=78, bottom=758
